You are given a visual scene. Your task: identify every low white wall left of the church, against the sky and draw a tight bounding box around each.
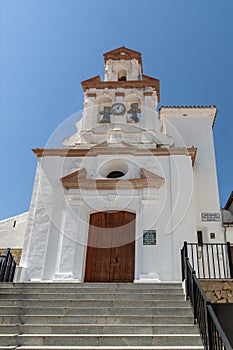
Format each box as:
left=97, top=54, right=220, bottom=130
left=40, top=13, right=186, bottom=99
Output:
left=0, top=212, right=28, bottom=248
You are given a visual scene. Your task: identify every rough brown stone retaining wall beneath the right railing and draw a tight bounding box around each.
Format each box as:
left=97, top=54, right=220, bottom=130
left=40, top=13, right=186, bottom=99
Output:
left=200, top=279, right=233, bottom=304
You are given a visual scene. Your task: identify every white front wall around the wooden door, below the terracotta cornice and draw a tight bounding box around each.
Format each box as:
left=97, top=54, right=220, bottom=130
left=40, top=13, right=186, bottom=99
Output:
left=17, top=150, right=196, bottom=282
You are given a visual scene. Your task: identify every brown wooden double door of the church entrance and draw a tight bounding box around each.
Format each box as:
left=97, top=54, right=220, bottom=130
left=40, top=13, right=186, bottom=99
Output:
left=85, top=211, right=136, bottom=282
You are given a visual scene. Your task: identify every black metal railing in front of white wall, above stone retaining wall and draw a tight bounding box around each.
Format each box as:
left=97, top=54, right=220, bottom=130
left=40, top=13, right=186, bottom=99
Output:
left=181, top=242, right=233, bottom=279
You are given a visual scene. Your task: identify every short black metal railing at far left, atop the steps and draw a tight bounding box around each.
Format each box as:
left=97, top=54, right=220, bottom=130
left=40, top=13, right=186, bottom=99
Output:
left=0, top=248, right=16, bottom=282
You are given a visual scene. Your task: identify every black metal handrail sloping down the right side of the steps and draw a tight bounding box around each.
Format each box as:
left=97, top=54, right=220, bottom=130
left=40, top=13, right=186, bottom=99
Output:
left=182, top=248, right=232, bottom=350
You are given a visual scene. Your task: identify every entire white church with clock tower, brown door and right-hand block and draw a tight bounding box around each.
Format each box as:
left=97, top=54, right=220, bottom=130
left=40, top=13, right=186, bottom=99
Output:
left=3, top=47, right=224, bottom=283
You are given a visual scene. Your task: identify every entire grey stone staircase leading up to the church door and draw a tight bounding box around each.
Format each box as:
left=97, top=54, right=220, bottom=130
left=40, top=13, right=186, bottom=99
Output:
left=0, top=283, right=203, bottom=350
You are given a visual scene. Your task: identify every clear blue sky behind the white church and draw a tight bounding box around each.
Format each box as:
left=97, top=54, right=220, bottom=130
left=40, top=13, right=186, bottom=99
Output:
left=0, top=0, right=233, bottom=219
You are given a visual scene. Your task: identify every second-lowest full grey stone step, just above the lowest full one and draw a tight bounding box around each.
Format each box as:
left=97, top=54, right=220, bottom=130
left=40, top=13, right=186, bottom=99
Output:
left=0, top=324, right=198, bottom=335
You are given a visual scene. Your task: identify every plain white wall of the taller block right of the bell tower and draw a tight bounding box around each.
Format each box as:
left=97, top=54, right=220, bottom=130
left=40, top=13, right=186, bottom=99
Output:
left=162, top=108, right=224, bottom=243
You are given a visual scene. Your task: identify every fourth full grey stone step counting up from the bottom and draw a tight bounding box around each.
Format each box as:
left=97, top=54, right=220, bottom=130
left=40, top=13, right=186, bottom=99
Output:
left=0, top=306, right=192, bottom=317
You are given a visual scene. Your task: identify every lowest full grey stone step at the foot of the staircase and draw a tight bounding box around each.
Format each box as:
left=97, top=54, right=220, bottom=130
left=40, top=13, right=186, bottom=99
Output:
left=0, top=334, right=202, bottom=347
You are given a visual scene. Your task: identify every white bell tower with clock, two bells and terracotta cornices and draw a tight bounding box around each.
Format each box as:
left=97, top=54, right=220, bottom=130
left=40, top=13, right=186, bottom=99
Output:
left=63, top=46, right=172, bottom=147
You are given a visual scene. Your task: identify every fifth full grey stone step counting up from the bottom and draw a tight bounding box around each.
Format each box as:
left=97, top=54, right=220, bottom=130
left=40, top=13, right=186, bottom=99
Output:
left=0, top=299, right=189, bottom=313
